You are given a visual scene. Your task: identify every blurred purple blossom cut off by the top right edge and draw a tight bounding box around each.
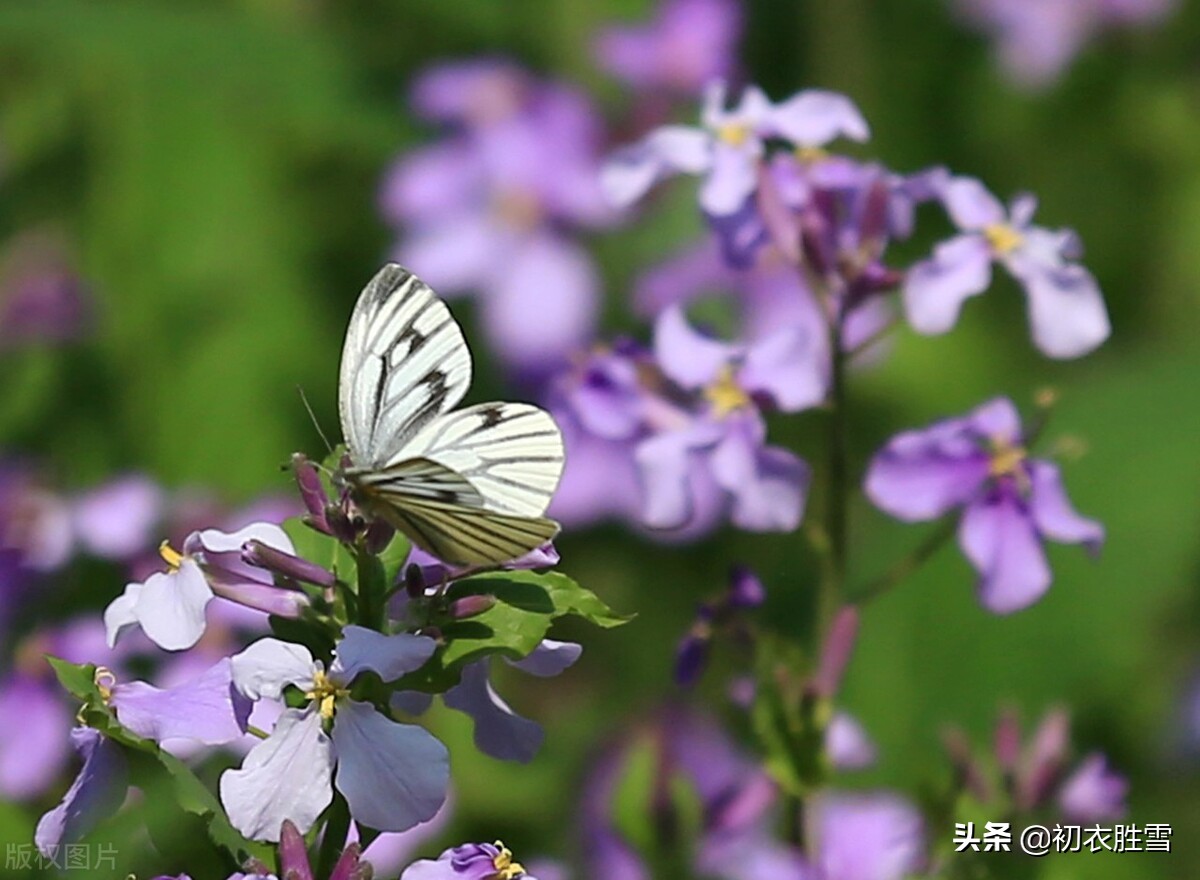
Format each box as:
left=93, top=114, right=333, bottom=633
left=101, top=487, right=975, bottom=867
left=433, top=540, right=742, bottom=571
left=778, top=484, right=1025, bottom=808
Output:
left=955, top=0, right=1176, bottom=89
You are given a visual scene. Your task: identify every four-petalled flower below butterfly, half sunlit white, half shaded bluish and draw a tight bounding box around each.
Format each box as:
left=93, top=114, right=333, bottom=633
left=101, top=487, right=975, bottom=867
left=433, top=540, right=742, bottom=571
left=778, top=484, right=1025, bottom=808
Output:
left=220, top=627, right=449, bottom=840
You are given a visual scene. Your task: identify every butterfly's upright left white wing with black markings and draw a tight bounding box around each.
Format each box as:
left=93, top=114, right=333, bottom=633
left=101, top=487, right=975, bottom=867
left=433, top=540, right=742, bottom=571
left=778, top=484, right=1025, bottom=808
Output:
left=338, top=263, right=470, bottom=466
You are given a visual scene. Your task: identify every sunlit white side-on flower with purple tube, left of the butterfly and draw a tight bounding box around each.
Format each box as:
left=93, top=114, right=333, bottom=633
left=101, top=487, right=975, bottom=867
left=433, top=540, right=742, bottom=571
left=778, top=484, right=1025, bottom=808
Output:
left=104, top=522, right=308, bottom=651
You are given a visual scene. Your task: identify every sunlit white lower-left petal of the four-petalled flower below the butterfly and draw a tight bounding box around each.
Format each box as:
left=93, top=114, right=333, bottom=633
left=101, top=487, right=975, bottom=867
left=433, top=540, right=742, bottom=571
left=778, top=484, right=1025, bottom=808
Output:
left=220, top=707, right=334, bottom=843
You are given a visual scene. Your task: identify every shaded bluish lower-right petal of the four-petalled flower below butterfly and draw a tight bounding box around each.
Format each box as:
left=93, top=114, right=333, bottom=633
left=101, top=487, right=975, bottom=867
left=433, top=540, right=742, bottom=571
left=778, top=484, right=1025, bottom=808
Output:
left=334, top=700, right=450, bottom=831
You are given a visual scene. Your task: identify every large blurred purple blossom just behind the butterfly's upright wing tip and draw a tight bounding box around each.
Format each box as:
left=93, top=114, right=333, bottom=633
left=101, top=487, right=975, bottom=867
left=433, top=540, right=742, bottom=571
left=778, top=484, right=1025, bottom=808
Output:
left=380, top=62, right=616, bottom=372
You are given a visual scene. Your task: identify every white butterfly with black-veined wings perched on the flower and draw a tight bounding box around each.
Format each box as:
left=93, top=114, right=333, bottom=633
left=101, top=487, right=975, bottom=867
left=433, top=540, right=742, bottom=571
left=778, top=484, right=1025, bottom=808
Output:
left=338, top=263, right=563, bottom=564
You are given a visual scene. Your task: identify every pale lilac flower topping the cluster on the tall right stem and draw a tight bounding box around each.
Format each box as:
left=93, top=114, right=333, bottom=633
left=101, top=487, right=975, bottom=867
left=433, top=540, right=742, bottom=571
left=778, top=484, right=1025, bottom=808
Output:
left=602, top=83, right=869, bottom=218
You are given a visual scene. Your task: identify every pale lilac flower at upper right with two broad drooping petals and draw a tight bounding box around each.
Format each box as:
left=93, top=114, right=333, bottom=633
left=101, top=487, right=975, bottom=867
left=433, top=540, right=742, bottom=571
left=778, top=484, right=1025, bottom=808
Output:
left=904, top=178, right=1110, bottom=358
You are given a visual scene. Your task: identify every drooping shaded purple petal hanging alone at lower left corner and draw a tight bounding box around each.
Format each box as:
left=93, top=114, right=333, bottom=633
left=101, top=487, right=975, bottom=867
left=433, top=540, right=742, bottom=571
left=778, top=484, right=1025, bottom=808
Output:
left=34, top=728, right=128, bottom=856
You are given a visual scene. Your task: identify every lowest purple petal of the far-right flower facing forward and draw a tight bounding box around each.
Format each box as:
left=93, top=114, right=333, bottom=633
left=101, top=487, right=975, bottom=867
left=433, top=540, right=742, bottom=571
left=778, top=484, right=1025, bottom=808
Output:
left=959, top=490, right=1050, bottom=613
